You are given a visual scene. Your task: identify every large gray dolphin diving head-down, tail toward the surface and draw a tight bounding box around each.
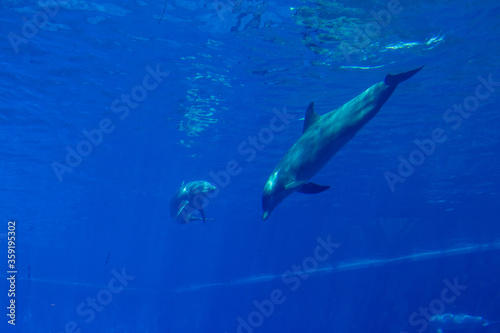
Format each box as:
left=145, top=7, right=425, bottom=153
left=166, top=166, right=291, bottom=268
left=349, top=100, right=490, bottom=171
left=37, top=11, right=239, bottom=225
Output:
left=262, top=66, right=423, bottom=220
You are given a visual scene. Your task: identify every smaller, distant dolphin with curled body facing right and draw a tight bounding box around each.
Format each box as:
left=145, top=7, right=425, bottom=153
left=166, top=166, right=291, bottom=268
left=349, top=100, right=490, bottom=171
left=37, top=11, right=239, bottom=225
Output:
left=170, top=180, right=216, bottom=224
